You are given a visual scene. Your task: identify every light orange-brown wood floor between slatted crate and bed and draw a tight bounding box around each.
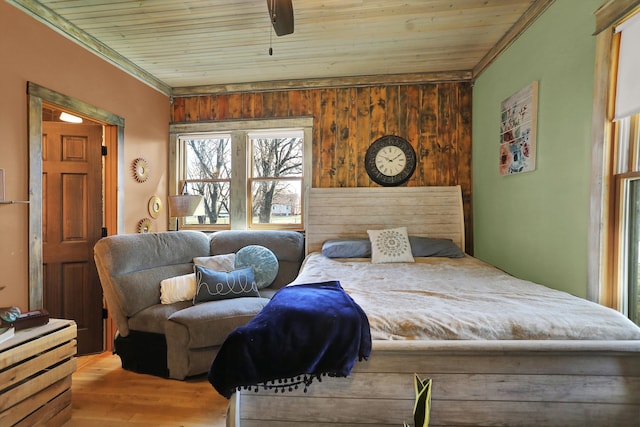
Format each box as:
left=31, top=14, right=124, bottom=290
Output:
left=64, top=353, right=228, bottom=427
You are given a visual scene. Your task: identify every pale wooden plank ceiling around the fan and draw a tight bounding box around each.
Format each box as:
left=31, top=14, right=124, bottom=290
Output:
left=8, top=0, right=546, bottom=90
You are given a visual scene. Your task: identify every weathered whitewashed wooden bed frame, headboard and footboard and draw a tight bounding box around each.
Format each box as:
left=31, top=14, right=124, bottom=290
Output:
left=227, top=186, right=640, bottom=427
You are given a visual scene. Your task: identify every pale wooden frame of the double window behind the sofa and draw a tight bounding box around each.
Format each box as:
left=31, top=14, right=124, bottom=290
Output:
left=167, top=116, right=313, bottom=231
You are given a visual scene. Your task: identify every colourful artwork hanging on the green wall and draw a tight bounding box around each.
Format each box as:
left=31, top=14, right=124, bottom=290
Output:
left=500, top=81, right=538, bottom=176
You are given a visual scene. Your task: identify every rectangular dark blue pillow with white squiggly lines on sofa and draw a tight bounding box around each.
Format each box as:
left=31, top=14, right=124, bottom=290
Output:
left=193, top=264, right=260, bottom=304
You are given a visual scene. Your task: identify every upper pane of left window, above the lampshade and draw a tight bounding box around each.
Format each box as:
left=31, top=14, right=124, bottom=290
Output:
left=182, top=135, right=231, bottom=180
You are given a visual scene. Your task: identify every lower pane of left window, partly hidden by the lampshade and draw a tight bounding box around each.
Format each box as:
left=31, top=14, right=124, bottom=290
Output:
left=184, top=182, right=230, bottom=225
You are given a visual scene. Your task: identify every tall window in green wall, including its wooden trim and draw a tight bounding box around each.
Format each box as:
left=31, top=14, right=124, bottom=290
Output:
left=587, top=2, right=640, bottom=323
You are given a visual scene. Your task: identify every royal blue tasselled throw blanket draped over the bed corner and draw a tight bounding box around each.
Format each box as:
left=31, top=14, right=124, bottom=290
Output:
left=208, top=281, right=371, bottom=399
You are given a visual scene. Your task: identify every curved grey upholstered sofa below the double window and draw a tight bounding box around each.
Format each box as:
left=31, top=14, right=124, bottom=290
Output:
left=94, top=230, right=304, bottom=380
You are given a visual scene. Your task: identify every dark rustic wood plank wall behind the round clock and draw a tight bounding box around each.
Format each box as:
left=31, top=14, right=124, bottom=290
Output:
left=171, top=82, right=473, bottom=254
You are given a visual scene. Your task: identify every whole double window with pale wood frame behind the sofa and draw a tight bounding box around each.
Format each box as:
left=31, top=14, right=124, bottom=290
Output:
left=169, top=118, right=312, bottom=230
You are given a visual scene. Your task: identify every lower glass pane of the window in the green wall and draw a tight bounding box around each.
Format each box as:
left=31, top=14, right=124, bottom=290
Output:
left=625, top=179, right=640, bottom=324
